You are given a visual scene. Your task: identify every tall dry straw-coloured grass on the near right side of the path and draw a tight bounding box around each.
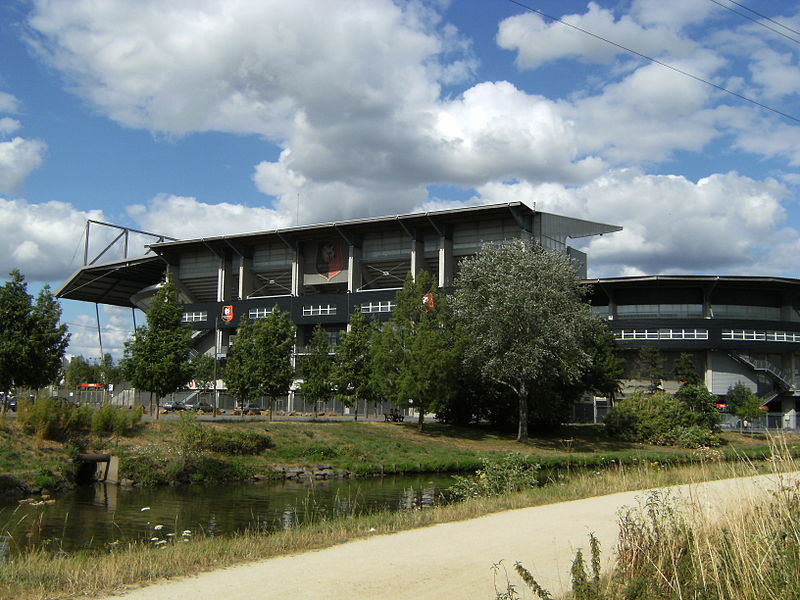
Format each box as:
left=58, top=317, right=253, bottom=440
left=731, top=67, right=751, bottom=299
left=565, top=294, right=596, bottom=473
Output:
left=495, top=438, right=800, bottom=600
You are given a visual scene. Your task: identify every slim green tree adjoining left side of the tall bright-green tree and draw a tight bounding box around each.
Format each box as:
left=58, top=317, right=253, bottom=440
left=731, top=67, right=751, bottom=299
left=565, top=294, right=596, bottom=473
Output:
left=331, top=311, right=376, bottom=421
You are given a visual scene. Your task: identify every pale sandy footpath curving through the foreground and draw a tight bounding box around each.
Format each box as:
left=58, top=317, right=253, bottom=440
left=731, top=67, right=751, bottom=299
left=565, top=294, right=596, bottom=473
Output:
left=97, top=473, right=800, bottom=600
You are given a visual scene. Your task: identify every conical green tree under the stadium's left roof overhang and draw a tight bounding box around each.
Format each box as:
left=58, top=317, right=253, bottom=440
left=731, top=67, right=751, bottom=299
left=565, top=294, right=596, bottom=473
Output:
left=123, top=281, right=192, bottom=414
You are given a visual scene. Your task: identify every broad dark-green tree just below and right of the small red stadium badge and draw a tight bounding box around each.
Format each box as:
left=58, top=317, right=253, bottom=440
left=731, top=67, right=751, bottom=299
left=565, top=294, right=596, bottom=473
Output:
left=224, top=307, right=295, bottom=420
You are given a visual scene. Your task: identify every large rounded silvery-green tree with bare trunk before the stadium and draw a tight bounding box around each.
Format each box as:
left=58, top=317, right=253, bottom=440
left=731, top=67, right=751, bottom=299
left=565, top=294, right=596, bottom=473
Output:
left=453, top=240, right=597, bottom=442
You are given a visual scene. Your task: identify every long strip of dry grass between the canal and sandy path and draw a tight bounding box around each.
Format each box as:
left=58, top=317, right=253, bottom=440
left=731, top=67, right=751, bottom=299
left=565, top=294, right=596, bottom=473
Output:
left=0, top=450, right=793, bottom=600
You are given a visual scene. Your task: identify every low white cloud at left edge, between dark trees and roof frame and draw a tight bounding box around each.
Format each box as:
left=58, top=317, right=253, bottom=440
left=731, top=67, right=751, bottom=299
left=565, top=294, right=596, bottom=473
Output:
left=0, top=198, right=102, bottom=282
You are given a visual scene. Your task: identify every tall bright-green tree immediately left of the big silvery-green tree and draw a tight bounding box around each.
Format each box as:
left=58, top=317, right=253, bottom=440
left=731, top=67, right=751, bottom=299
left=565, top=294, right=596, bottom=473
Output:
left=372, top=271, right=460, bottom=430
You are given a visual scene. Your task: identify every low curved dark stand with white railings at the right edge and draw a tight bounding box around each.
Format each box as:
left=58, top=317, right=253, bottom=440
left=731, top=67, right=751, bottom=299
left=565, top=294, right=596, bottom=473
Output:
left=586, top=275, right=800, bottom=429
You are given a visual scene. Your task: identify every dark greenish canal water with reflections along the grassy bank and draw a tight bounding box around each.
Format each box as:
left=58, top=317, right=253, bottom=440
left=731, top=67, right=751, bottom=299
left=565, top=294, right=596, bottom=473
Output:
left=0, top=475, right=451, bottom=554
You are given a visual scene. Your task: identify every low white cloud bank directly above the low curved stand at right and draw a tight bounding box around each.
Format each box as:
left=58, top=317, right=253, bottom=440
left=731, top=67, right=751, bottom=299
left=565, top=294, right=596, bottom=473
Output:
left=479, top=169, right=800, bottom=276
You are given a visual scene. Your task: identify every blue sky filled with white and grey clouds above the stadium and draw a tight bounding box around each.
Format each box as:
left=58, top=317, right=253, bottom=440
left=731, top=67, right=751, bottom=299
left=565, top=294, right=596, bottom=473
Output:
left=0, top=0, right=800, bottom=356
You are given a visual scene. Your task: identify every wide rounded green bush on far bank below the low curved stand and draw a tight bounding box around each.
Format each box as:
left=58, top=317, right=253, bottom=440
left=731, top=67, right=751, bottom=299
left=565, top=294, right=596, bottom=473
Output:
left=605, top=386, right=719, bottom=448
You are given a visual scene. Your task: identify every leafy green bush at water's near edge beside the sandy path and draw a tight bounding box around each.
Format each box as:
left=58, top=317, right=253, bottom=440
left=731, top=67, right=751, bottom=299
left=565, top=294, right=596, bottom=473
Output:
left=449, top=452, right=541, bottom=500
